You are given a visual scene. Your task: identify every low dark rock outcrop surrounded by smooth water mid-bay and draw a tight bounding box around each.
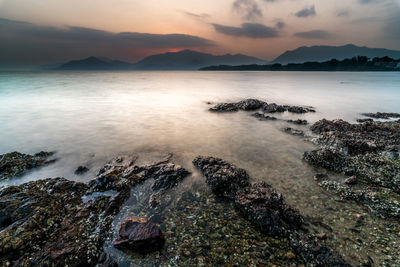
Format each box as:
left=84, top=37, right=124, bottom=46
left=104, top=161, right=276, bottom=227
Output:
left=210, top=98, right=315, bottom=114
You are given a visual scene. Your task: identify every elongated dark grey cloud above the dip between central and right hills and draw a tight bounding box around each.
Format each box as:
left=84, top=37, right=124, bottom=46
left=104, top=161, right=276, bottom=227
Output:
left=212, top=23, right=279, bottom=38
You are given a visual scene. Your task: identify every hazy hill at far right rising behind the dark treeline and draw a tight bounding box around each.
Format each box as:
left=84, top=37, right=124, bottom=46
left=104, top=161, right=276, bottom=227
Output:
left=272, top=44, right=400, bottom=64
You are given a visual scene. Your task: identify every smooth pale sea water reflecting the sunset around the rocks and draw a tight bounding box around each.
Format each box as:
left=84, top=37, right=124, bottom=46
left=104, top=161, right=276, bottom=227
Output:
left=0, top=72, right=400, bottom=264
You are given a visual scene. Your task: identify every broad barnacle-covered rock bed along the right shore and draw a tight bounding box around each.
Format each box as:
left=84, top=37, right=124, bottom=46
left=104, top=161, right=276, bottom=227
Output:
left=304, top=118, right=400, bottom=217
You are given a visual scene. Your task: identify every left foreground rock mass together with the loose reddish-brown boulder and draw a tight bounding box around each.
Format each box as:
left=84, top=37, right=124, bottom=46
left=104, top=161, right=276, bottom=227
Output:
left=0, top=154, right=189, bottom=266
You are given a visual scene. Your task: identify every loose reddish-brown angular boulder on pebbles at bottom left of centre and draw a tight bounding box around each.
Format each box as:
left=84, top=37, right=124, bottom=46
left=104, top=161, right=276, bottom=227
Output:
left=113, top=217, right=165, bottom=254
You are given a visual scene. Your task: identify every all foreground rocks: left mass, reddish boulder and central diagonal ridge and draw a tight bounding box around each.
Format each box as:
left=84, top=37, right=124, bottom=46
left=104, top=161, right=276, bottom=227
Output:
left=0, top=151, right=347, bottom=266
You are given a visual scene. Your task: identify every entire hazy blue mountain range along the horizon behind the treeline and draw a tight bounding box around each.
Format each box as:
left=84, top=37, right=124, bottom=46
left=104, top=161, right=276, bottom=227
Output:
left=47, top=44, right=400, bottom=70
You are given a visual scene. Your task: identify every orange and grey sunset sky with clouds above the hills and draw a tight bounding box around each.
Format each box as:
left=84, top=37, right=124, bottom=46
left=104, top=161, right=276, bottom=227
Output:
left=0, top=0, right=400, bottom=67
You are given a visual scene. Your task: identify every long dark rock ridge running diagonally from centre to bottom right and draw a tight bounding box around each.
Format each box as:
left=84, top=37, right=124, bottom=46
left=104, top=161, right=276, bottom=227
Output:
left=193, top=157, right=349, bottom=266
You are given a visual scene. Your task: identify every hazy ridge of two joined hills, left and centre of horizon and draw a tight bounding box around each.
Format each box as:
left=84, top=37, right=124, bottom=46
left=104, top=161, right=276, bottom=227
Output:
left=54, top=50, right=266, bottom=70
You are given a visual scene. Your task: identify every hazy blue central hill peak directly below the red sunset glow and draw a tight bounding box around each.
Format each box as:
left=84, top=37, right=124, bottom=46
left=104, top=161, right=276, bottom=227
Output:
left=135, top=50, right=266, bottom=70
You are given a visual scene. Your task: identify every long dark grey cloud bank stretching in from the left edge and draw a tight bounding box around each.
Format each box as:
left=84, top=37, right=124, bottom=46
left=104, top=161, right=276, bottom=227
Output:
left=0, top=18, right=215, bottom=66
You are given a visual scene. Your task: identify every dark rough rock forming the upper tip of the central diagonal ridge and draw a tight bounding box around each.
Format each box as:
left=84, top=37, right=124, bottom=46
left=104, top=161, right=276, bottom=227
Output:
left=193, top=157, right=250, bottom=199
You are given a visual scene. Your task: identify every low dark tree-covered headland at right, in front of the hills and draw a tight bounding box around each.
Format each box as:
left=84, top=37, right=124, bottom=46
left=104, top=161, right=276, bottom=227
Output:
left=200, top=56, right=400, bottom=71
